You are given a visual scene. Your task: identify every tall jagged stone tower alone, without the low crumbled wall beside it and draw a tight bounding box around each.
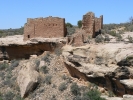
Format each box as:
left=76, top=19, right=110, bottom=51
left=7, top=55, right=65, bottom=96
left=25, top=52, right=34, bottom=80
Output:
left=82, top=12, right=103, bottom=38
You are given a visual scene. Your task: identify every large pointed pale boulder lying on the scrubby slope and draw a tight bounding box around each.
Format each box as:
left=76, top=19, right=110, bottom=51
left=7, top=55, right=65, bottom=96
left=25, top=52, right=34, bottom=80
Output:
left=17, top=62, right=39, bottom=97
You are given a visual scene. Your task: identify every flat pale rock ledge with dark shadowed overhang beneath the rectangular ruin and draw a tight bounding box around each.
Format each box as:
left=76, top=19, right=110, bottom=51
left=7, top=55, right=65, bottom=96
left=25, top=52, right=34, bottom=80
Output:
left=0, top=36, right=66, bottom=60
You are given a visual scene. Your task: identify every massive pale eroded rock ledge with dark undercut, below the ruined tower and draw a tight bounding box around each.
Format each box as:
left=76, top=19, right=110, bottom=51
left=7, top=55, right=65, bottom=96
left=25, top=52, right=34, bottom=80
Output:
left=62, top=43, right=133, bottom=96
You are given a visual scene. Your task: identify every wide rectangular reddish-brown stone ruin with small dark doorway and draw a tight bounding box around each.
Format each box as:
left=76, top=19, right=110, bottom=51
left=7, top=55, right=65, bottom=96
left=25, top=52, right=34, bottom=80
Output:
left=24, top=16, right=66, bottom=41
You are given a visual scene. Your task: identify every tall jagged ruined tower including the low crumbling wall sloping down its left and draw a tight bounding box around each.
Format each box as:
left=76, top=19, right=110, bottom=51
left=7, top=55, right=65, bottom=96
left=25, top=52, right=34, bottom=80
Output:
left=71, top=12, right=103, bottom=46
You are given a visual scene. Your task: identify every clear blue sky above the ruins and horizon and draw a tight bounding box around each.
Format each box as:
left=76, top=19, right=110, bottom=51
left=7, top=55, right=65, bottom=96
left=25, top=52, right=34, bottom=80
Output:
left=0, top=0, right=133, bottom=29
